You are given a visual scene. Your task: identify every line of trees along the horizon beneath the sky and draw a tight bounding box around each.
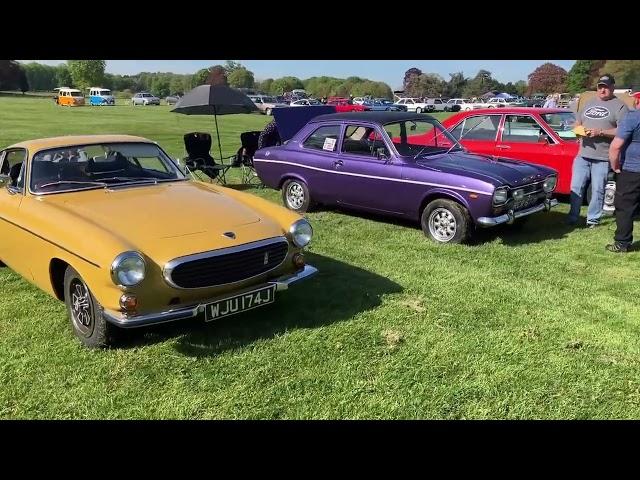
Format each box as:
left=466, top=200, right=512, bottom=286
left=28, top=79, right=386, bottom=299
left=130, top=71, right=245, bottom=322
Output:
left=0, top=60, right=640, bottom=98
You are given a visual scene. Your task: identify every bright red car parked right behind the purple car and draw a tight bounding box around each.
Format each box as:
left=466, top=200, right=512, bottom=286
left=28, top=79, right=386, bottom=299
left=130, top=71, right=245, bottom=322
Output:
left=442, top=107, right=579, bottom=194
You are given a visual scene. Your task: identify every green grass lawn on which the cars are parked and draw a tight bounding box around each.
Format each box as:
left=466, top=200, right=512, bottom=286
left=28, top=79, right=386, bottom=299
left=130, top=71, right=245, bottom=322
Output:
left=0, top=97, right=640, bottom=419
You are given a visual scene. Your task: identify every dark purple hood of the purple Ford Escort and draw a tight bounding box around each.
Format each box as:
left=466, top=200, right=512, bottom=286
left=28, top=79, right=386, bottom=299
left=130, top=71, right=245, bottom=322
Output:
left=416, top=152, right=555, bottom=187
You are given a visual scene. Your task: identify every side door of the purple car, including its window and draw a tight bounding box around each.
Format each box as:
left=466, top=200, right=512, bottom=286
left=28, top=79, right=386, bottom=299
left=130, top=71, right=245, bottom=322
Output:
left=334, top=123, right=402, bottom=214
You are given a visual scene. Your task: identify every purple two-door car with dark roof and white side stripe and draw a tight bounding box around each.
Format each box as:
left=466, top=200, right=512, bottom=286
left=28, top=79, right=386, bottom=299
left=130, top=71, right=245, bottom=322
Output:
left=254, top=107, right=558, bottom=243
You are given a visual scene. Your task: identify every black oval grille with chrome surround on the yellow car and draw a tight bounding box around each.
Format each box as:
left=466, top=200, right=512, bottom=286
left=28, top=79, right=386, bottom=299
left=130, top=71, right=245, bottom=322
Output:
left=164, top=237, right=289, bottom=288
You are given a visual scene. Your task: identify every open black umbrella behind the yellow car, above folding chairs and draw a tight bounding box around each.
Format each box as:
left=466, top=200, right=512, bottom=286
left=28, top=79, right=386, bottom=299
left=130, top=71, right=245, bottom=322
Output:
left=171, top=85, right=258, bottom=161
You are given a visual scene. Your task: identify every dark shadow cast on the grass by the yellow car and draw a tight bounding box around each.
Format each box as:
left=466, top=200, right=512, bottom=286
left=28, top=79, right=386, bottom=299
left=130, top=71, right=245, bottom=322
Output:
left=118, top=253, right=403, bottom=356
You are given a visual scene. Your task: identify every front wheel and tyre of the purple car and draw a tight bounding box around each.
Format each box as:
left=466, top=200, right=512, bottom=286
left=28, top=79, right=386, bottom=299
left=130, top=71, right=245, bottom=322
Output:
left=420, top=198, right=472, bottom=243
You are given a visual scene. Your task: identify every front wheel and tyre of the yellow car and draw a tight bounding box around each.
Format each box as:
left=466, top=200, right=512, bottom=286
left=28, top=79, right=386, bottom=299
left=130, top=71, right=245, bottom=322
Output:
left=64, top=267, right=117, bottom=348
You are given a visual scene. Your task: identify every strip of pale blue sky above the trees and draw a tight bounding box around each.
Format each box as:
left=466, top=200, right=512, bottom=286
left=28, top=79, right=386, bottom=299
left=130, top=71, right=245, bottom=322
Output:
left=19, top=59, right=575, bottom=90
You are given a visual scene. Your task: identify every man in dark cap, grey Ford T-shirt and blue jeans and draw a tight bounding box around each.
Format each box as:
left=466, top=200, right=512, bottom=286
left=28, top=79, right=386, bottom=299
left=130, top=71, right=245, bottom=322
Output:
left=567, top=74, right=629, bottom=228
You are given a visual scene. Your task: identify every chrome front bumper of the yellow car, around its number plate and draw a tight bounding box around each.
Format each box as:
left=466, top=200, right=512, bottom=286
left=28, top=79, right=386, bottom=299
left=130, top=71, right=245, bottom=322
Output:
left=102, top=265, right=318, bottom=328
